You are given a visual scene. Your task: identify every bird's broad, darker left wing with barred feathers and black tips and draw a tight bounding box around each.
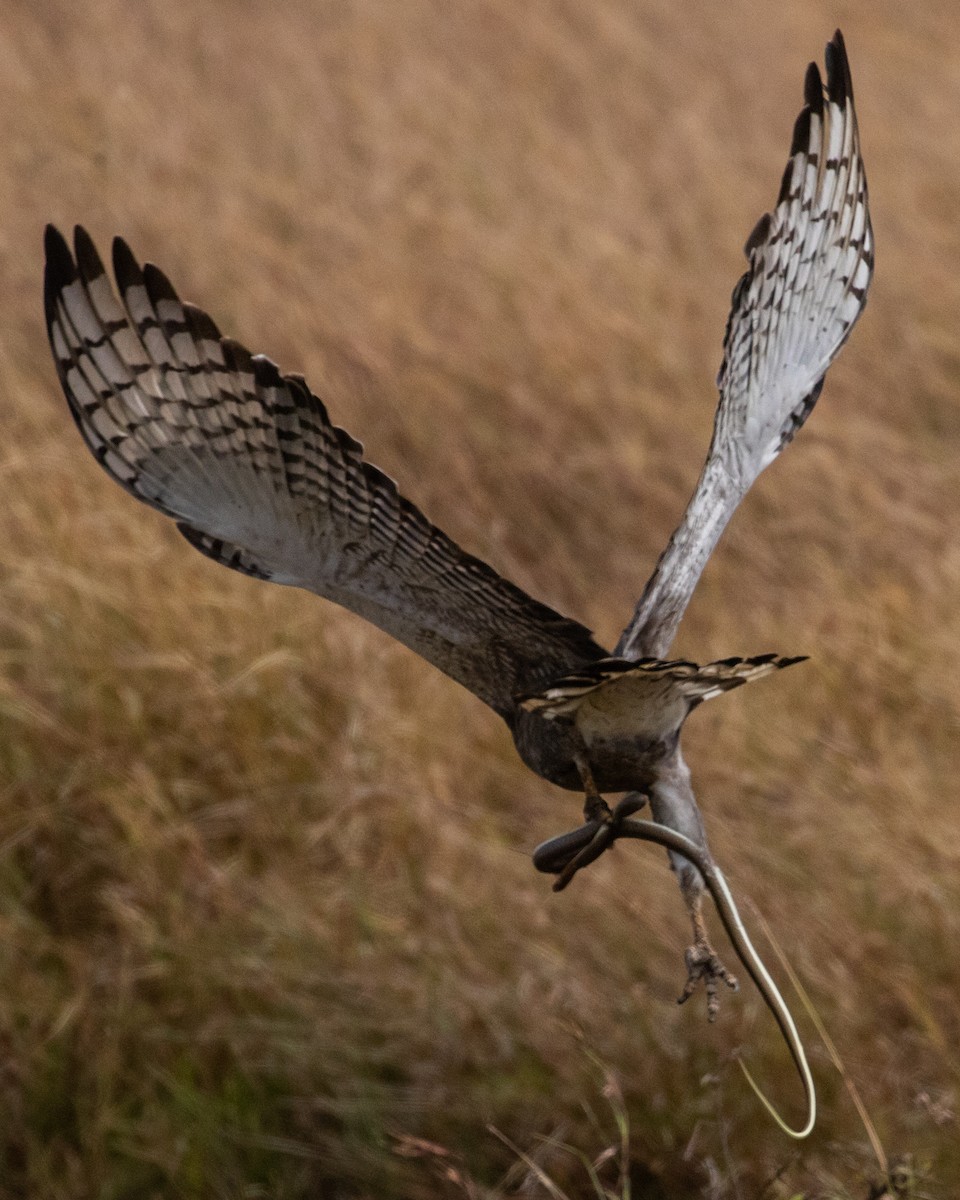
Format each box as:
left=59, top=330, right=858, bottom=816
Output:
left=44, top=227, right=605, bottom=719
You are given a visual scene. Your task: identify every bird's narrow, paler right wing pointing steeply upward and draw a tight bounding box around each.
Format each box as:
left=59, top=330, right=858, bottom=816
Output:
left=614, top=30, right=874, bottom=658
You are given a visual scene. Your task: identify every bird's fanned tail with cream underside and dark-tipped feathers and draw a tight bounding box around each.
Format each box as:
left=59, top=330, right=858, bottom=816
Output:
left=518, top=654, right=804, bottom=740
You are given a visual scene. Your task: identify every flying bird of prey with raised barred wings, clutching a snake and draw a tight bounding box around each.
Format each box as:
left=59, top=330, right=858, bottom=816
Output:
left=44, top=31, right=874, bottom=1108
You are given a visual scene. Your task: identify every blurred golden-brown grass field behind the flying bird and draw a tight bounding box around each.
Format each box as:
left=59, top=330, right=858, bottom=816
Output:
left=0, top=0, right=960, bottom=1200
